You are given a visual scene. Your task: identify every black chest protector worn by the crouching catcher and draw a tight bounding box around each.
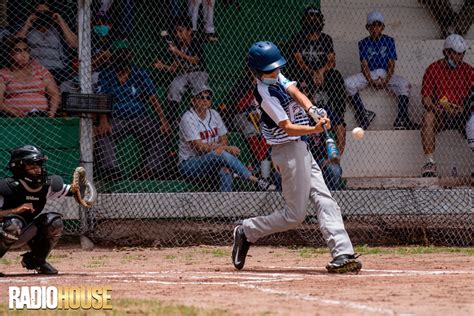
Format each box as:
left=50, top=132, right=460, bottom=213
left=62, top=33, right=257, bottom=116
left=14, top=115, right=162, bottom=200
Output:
left=0, top=178, right=49, bottom=223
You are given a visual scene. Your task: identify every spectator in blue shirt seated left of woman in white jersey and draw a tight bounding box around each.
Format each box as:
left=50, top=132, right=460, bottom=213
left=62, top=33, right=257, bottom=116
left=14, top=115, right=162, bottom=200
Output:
left=95, top=43, right=170, bottom=179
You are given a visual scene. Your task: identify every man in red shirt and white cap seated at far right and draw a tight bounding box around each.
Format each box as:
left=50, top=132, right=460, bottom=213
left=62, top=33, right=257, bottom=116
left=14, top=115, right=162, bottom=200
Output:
left=421, top=34, right=474, bottom=177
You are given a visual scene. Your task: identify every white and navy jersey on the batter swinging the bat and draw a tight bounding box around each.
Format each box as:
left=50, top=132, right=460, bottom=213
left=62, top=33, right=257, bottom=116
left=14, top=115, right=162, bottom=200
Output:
left=254, top=74, right=309, bottom=145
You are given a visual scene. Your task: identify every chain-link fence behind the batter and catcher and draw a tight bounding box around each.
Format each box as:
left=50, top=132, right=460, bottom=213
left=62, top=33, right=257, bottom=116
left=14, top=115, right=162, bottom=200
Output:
left=0, top=0, right=474, bottom=246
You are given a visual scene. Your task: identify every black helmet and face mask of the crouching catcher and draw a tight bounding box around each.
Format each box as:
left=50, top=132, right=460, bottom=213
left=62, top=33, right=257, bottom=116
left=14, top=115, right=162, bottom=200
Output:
left=7, top=145, right=48, bottom=188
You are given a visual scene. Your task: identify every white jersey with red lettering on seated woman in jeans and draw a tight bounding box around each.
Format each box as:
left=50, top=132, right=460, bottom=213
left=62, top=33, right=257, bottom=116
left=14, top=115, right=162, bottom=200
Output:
left=179, top=109, right=227, bottom=161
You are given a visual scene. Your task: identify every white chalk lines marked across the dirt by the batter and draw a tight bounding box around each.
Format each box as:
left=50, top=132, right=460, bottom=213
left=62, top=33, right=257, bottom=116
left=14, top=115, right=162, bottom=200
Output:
left=0, top=267, right=474, bottom=315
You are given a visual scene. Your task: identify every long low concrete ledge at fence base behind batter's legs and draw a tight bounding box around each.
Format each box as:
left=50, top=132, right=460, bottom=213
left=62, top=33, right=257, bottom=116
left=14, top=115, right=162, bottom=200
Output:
left=90, top=188, right=472, bottom=220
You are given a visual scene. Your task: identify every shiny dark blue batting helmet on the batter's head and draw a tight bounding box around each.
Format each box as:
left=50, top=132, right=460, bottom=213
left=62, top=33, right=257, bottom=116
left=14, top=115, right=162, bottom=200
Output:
left=248, top=42, right=286, bottom=72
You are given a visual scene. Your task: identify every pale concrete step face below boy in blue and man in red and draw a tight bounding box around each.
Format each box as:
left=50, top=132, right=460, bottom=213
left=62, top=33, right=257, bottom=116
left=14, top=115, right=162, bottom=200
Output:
left=341, top=128, right=474, bottom=178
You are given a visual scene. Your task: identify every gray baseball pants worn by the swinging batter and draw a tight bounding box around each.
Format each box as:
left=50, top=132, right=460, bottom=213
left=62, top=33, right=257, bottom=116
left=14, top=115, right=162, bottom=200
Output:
left=242, top=140, right=354, bottom=258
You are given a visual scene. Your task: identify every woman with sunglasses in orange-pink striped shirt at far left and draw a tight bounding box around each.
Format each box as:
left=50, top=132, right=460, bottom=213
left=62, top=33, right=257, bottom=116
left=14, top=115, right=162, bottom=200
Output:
left=0, top=37, right=60, bottom=117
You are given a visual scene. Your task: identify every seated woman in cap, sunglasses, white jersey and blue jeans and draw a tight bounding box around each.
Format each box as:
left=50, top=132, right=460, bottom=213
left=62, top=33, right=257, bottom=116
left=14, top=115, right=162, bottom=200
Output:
left=178, top=86, right=275, bottom=192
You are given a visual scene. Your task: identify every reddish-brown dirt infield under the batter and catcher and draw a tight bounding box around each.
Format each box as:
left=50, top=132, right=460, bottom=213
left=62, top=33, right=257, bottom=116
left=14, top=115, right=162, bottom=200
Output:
left=0, top=246, right=474, bottom=316
